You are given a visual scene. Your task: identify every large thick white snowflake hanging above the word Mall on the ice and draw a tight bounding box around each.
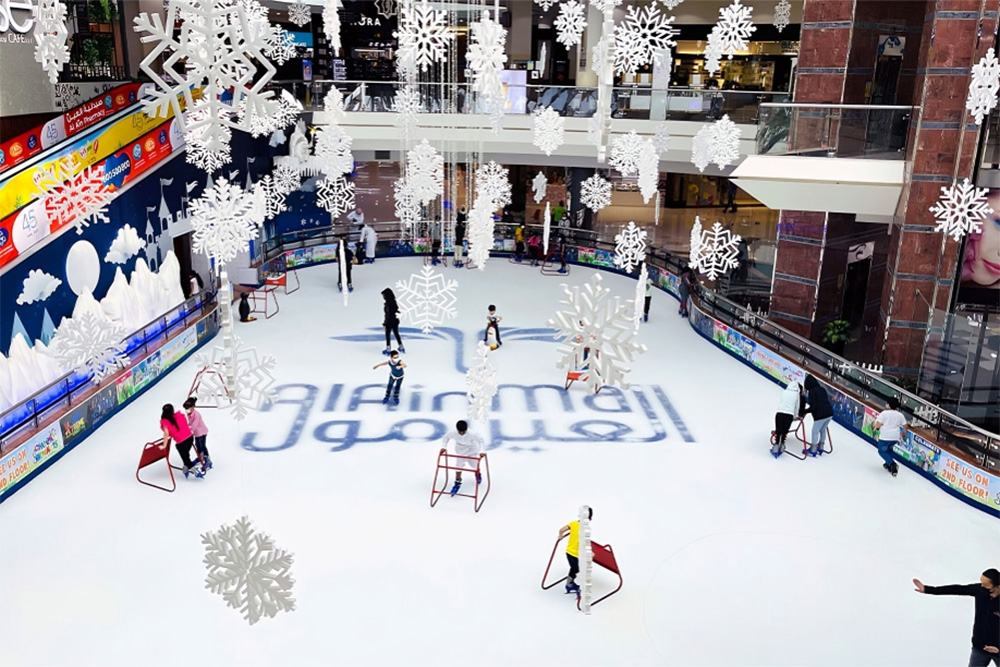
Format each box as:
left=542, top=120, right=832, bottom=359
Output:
left=548, top=273, right=646, bottom=391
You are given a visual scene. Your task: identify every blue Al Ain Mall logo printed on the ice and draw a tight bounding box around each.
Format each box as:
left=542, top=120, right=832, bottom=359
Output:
left=240, top=327, right=695, bottom=452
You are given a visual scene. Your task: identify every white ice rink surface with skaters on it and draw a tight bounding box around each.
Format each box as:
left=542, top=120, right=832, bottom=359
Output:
left=0, top=258, right=1000, bottom=667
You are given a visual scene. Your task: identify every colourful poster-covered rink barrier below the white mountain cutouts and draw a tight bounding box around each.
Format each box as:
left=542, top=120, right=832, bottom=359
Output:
left=0, top=308, right=219, bottom=504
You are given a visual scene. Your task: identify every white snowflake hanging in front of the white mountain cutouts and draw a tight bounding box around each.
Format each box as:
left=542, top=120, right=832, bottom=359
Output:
left=53, top=312, right=129, bottom=384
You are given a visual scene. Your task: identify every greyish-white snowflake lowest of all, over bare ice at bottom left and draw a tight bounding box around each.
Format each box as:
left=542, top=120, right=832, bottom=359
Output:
left=201, top=517, right=295, bottom=625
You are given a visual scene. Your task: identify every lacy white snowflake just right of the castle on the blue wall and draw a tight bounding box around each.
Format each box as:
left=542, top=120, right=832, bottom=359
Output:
left=188, top=177, right=264, bottom=264
